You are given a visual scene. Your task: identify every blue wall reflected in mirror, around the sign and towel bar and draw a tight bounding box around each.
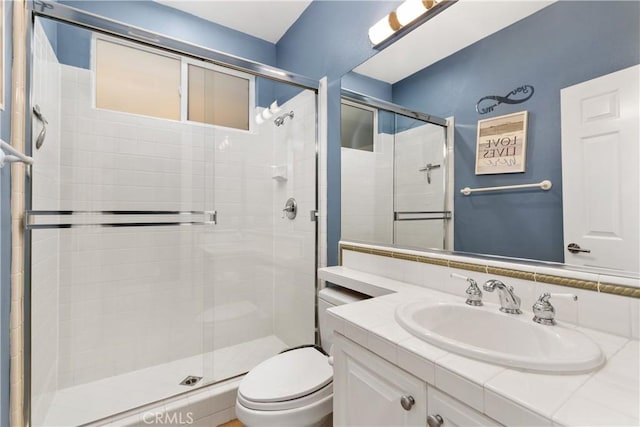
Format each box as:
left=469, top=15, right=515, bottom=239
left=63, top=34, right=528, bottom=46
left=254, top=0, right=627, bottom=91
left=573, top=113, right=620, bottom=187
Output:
left=393, top=1, right=640, bottom=262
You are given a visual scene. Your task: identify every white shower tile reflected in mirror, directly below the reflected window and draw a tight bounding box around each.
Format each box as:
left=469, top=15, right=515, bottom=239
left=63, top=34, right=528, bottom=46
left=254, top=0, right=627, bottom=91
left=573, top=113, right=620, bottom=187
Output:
left=341, top=134, right=393, bottom=244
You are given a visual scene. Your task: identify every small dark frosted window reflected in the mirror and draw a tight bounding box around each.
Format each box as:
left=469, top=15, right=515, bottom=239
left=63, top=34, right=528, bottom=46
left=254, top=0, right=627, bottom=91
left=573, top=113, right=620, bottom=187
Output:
left=340, top=103, right=375, bottom=151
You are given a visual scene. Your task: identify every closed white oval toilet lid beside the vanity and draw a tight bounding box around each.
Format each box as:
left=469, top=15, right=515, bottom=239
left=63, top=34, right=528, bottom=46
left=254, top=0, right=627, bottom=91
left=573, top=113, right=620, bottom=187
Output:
left=238, top=347, right=333, bottom=402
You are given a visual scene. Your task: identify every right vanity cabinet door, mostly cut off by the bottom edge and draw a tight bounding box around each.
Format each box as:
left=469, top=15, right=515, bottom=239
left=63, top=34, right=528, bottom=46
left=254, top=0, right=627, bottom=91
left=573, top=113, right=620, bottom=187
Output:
left=428, top=387, right=501, bottom=427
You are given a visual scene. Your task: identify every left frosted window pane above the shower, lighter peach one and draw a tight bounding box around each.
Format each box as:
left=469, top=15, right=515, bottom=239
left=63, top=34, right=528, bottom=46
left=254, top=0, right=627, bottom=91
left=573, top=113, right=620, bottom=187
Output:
left=95, top=39, right=181, bottom=120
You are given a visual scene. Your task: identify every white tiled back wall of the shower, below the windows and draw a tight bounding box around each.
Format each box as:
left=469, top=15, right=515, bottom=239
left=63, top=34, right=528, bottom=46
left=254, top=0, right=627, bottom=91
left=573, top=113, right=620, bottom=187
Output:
left=52, top=65, right=290, bottom=388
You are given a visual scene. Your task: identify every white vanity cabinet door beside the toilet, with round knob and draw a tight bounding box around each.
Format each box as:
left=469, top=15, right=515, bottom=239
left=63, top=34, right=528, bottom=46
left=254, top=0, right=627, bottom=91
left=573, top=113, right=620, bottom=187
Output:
left=333, top=334, right=427, bottom=427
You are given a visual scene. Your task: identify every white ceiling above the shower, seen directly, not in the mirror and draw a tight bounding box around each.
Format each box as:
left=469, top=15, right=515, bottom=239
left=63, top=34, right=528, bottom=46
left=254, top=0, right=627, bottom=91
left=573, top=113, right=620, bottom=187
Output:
left=156, top=0, right=311, bottom=43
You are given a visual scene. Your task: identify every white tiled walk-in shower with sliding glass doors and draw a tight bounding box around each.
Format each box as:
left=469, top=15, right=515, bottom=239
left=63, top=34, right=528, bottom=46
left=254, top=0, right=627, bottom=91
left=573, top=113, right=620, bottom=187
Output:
left=26, top=6, right=317, bottom=426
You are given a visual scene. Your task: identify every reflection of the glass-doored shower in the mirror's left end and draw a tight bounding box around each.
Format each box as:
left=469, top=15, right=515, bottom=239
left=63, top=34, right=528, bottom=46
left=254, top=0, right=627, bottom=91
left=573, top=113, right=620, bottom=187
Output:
left=340, top=90, right=452, bottom=249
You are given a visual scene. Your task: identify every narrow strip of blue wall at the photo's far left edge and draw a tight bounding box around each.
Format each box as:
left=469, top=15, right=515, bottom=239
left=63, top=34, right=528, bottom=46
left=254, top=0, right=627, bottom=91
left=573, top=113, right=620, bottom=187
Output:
left=0, top=1, right=13, bottom=427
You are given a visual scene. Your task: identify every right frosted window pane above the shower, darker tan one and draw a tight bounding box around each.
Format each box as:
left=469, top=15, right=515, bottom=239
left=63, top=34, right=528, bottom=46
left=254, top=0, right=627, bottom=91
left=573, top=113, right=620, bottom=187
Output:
left=187, top=65, right=249, bottom=130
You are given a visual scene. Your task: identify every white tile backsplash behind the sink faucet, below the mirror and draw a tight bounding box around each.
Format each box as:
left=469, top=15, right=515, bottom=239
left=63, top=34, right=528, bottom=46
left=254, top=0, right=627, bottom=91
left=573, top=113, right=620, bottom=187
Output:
left=342, top=248, right=640, bottom=339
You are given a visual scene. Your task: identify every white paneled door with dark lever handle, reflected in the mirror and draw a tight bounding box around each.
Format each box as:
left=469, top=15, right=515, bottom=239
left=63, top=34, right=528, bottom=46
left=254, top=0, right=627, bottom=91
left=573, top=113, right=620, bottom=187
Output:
left=561, top=66, right=640, bottom=272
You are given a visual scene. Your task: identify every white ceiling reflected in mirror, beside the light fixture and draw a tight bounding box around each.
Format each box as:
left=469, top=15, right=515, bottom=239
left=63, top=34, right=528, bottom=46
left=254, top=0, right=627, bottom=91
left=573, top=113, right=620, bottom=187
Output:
left=353, top=0, right=555, bottom=83
